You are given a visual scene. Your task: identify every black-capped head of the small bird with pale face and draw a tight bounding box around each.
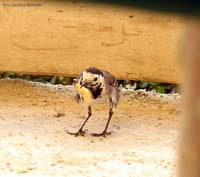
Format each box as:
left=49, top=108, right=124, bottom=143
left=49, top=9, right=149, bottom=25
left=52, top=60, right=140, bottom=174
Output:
left=80, top=67, right=104, bottom=88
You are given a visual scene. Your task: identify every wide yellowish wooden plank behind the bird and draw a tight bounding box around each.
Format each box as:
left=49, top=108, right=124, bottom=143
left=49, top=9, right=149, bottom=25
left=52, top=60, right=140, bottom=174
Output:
left=0, top=0, right=184, bottom=83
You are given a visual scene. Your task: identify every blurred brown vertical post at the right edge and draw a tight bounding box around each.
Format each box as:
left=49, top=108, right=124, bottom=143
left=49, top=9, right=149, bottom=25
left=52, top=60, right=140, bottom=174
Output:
left=179, top=20, right=200, bottom=177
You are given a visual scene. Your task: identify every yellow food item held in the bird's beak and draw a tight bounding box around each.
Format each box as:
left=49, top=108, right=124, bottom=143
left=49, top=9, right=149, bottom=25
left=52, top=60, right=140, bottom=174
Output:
left=75, top=84, right=92, bottom=105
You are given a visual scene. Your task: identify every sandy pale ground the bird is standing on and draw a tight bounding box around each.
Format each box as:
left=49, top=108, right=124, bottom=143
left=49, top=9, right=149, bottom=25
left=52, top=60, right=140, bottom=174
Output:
left=0, top=80, right=181, bottom=177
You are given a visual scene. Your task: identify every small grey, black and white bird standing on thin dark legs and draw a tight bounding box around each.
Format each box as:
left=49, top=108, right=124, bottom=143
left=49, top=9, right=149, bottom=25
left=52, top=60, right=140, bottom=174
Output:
left=67, top=67, right=120, bottom=137
